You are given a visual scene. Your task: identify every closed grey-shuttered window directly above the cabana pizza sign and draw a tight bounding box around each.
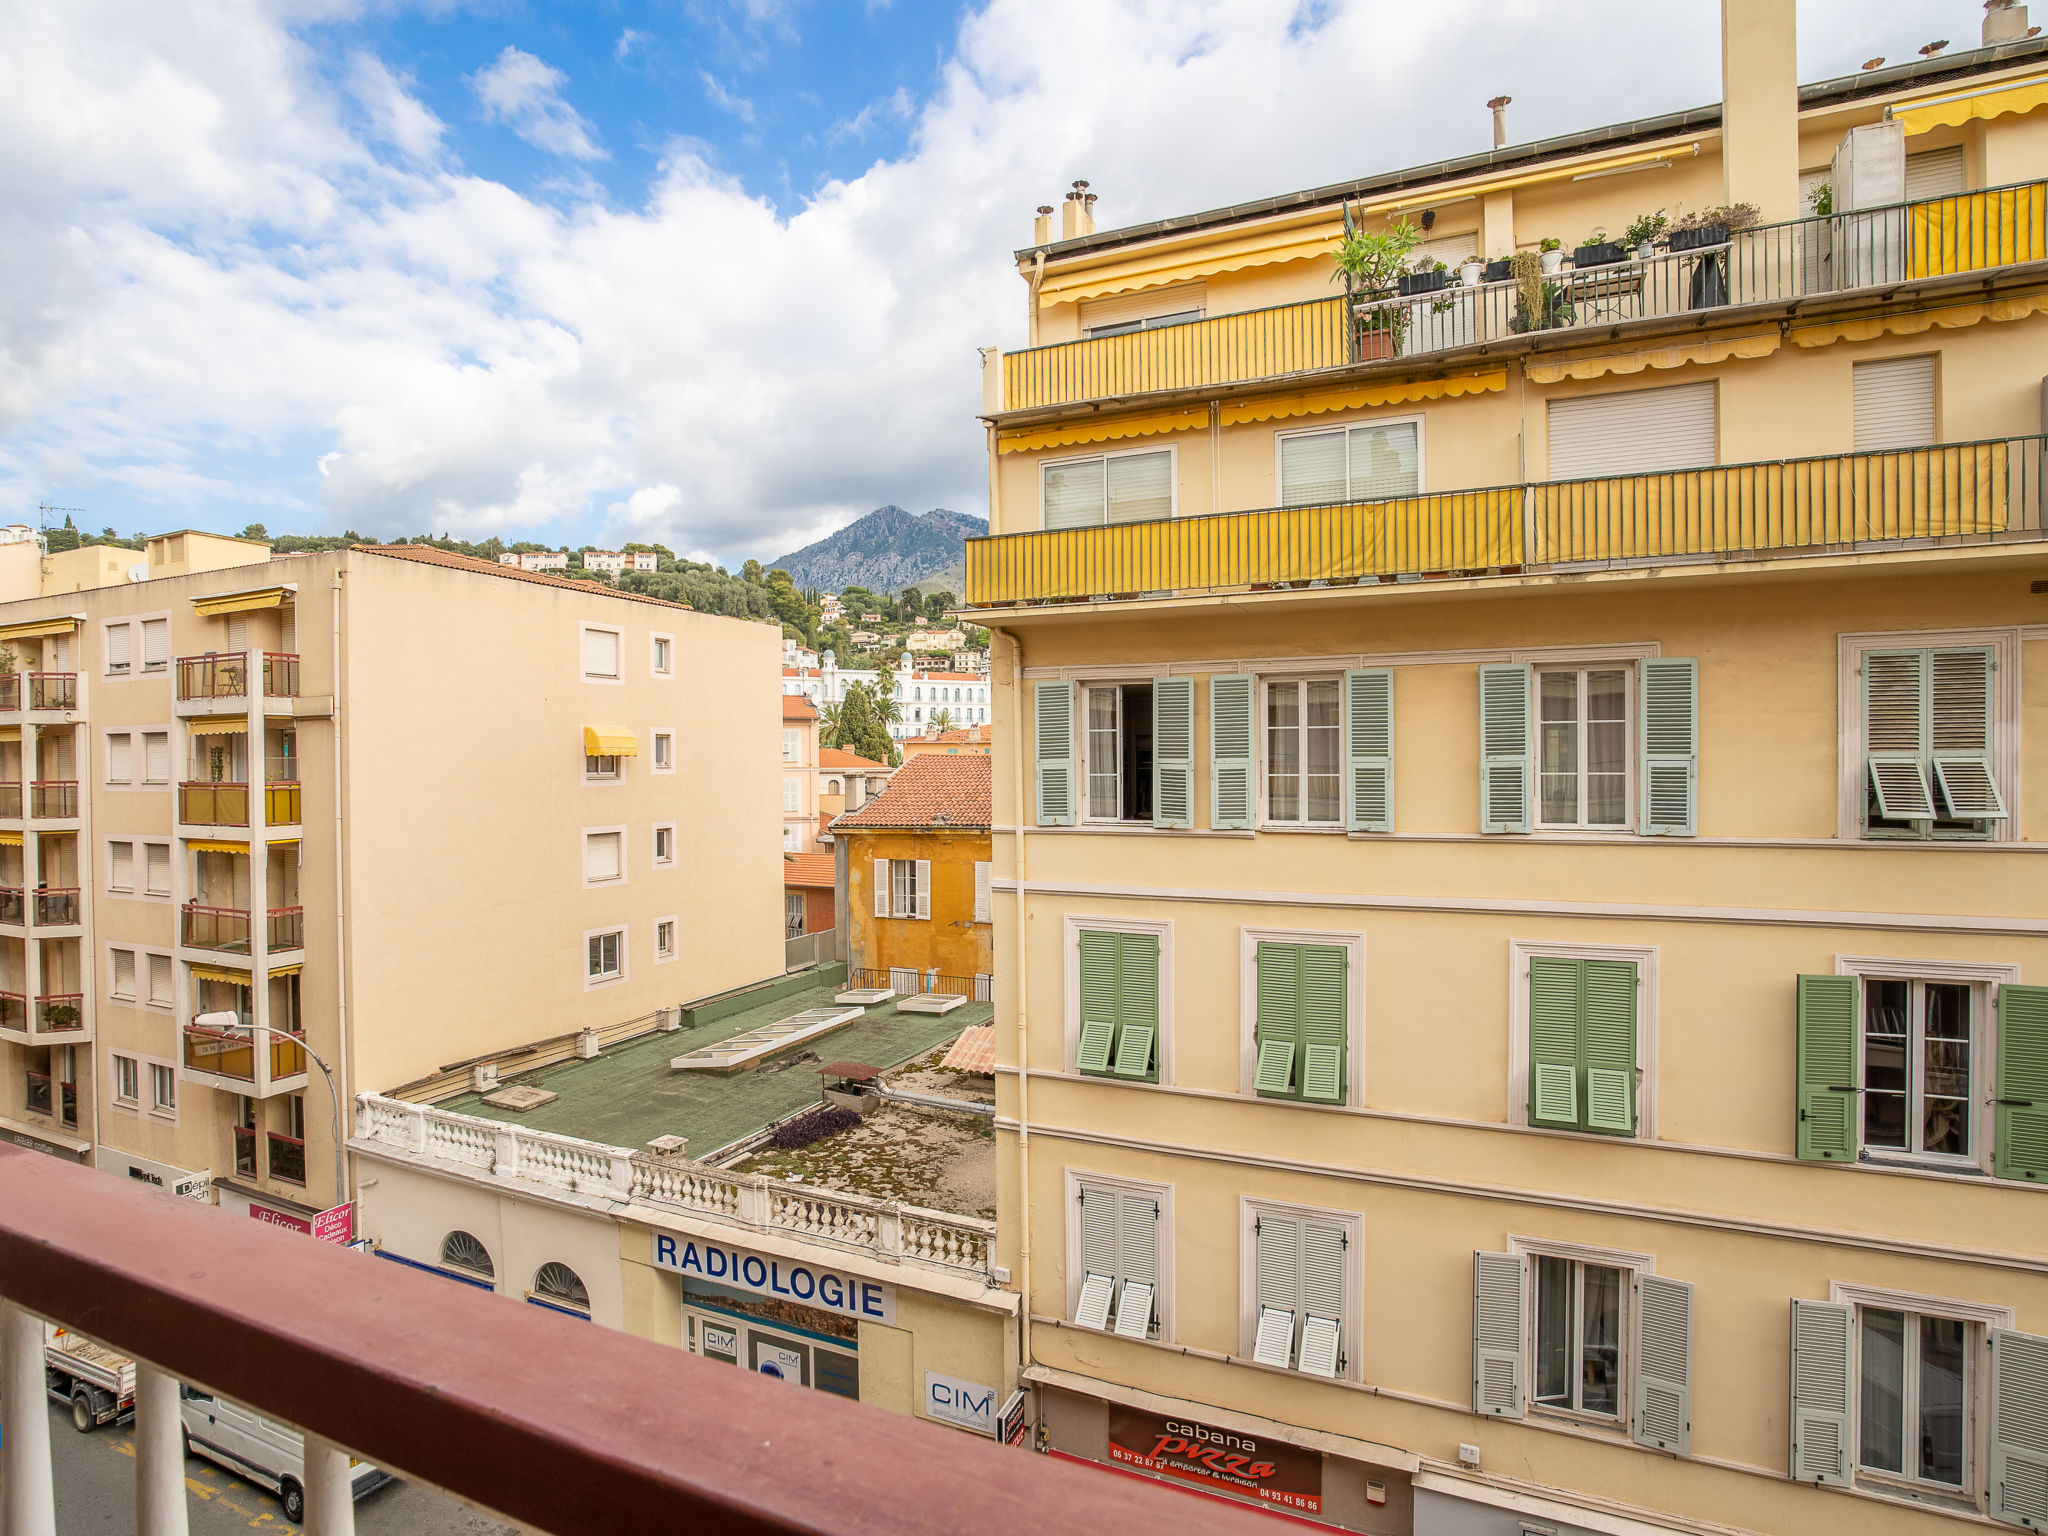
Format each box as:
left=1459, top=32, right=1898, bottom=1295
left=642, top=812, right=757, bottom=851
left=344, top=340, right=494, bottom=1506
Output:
left=1245, top=1206, right=1356, bottom=1376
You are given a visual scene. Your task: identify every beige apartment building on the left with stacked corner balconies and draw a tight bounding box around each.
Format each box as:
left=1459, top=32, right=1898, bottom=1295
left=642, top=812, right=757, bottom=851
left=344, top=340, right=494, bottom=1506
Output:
left=0, top=535, right=782, bottom=1225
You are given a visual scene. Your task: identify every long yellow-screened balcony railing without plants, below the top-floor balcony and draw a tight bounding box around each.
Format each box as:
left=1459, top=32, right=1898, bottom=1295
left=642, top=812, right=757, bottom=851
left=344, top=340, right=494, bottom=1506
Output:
left=967, top=438, right=2048, bottom=606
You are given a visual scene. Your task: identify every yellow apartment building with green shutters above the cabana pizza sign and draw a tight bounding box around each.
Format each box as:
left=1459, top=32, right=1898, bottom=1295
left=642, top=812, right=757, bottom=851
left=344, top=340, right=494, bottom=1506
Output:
left=970, top=12, right=2048, bottom=1536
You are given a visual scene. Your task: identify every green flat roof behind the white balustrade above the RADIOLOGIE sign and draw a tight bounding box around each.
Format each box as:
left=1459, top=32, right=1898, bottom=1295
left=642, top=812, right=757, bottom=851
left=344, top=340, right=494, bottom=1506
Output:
left=436, top=981, right=995, bottom=1157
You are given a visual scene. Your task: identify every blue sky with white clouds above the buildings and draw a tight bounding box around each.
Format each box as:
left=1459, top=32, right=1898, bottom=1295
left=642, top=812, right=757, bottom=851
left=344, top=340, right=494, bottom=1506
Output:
left=0, top=0, right=1982, bottom=567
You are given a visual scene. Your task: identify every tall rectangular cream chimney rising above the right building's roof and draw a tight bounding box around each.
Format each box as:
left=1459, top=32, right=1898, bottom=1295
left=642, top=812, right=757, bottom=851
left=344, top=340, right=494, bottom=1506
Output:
left=1720, top=0, right=1800, bottom=223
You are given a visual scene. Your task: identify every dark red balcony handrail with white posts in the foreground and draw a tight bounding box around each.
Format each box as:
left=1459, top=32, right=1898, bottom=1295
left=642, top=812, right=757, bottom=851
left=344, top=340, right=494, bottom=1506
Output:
left=0, top=1147, right=1245, bottom=1536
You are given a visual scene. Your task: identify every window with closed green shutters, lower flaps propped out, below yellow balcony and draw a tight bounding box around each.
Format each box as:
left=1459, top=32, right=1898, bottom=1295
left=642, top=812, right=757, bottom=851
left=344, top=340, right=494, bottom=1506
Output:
left=1862, top=645, right=2007, bottom=838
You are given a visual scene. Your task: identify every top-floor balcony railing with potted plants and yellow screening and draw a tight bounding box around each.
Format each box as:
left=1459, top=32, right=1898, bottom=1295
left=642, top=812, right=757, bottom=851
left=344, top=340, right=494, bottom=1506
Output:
left=1004, top=182, right=2048, bottom=412
